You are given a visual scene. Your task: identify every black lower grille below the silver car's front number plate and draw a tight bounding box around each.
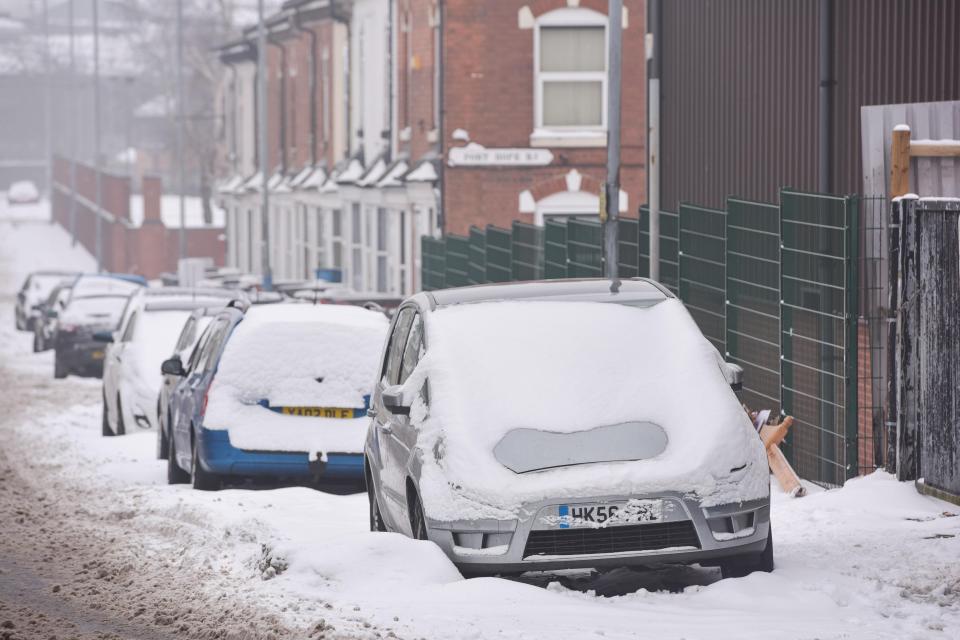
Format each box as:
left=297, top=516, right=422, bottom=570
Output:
left=523, top=520, right=700, bottom=558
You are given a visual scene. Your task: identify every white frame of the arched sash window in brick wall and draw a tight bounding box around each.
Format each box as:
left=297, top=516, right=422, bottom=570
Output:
left=530, top=7, right=610, bottom=147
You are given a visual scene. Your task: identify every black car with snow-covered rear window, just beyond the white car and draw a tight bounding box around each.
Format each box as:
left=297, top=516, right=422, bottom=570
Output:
left=53, top=275, right=141, bottom=378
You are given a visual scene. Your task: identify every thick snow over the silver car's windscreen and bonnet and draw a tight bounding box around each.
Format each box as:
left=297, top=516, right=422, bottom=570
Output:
left=407, top=300, right=769, bottom=520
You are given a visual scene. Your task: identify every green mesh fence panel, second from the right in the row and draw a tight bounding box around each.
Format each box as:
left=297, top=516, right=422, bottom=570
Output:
left=726, top=198, right=780, bottom=411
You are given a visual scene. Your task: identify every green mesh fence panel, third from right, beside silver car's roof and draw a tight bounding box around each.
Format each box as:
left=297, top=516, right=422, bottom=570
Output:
left=677, top=204, right=727, bottom=353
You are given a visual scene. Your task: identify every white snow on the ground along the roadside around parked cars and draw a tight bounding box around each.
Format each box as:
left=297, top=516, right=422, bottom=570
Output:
left=0, top=202, right=960, bottom=639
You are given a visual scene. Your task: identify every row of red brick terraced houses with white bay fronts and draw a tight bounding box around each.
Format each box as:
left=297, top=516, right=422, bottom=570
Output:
left=220, top=0, right=646, bottom=295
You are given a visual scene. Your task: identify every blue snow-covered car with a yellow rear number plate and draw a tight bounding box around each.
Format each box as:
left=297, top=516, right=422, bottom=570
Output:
left=163, top=304, right=389, bottom=489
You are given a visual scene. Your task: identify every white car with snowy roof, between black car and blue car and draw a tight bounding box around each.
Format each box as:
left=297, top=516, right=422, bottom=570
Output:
left=94, top=287, right=240, bottom=436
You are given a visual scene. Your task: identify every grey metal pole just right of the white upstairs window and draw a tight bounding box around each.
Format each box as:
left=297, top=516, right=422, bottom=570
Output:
left=603, top=0, right=623, bottom=279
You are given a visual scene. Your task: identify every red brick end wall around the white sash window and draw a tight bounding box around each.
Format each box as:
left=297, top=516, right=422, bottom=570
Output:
left=438, top=0, right=646, bottom=233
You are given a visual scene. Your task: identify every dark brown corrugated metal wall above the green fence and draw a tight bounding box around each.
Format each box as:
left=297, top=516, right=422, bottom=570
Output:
left=660, top=0, right=960, bottom=210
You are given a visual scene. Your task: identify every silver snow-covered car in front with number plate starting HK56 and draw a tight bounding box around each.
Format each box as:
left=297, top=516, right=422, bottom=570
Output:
left=365, top=279, right=773, bottom=576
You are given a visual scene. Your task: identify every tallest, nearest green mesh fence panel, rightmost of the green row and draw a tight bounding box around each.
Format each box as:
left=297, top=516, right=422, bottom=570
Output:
left=780, top=190, right=858, bottom=485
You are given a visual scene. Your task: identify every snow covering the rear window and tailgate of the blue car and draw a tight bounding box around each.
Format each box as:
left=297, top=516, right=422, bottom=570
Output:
left=204, top=305, right=388, bottom=453
